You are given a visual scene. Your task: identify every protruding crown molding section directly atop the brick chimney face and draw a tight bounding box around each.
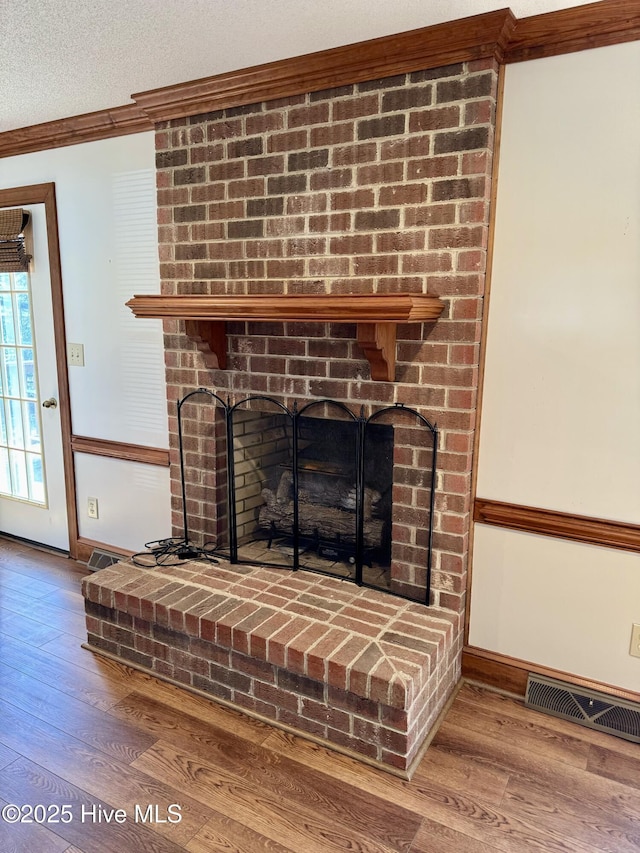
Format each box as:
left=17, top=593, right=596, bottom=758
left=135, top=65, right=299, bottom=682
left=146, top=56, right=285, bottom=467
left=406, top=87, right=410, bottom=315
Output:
left=132, top=9, right=516, bottom=122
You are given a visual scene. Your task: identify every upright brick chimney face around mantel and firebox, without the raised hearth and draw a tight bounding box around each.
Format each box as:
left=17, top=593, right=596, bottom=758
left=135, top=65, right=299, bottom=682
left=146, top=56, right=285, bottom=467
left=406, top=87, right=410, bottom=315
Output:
left=156, top=60, right=497, bottom=612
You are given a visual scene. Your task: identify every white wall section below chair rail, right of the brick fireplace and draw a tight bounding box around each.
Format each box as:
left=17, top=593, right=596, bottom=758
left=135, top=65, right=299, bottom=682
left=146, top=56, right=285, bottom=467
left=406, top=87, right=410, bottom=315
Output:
left=469, top=524, right=640, bottom=692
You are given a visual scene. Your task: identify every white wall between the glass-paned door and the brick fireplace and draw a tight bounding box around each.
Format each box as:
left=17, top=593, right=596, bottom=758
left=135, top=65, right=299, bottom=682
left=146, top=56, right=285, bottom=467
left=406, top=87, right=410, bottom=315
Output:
left=0, top=132, right=170, bottom=550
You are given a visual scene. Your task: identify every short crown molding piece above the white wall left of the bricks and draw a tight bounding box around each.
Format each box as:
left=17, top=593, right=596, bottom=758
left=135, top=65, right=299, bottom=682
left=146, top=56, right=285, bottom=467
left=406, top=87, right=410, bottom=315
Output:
left=0, top=104, right=153, bottom=157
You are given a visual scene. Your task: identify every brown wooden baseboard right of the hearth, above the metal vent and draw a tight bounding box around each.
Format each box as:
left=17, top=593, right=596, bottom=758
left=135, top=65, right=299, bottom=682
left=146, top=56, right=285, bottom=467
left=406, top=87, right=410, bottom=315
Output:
left=462, top=646, right=640, bottom=702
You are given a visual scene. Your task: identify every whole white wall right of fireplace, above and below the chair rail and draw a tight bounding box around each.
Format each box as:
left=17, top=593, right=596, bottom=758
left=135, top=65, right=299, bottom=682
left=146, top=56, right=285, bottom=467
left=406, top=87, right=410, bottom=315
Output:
left=469, top=42, right=640, bottom=691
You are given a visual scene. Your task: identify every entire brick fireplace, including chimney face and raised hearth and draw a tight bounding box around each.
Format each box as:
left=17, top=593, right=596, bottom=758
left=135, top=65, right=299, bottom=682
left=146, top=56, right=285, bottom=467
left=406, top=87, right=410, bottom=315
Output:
left=87, top=53, right=498, bottom=772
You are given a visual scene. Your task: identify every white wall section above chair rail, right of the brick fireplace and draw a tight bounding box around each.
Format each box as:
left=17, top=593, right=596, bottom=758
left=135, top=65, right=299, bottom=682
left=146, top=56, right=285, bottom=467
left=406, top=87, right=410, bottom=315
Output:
left=478, top=42, right=640, bottom=523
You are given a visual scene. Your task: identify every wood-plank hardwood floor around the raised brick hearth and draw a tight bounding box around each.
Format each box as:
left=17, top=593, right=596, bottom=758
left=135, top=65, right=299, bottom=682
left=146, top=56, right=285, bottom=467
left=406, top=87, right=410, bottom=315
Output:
left=0, top=539, right=640, bottom=853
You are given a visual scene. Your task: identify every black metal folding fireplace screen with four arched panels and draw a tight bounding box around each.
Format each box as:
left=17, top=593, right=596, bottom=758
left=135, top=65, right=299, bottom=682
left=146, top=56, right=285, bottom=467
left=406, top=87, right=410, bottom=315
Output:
left=178, top=388, right=438, bottom=604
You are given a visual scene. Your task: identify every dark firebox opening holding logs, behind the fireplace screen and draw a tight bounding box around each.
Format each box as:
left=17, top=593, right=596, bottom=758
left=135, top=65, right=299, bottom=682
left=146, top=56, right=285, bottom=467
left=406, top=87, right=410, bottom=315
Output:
left=233, top=412, right=393, bottom=589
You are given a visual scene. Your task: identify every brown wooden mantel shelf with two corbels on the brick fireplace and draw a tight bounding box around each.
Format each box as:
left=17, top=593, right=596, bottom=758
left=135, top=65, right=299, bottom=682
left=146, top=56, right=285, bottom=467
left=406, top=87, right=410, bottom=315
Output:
left=127, top=293, right=444, bottom=382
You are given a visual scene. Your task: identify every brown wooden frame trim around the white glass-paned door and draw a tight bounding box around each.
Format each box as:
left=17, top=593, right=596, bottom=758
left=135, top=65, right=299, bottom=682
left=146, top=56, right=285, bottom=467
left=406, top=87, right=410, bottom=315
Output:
left=0, top=182, right=79, bottom=560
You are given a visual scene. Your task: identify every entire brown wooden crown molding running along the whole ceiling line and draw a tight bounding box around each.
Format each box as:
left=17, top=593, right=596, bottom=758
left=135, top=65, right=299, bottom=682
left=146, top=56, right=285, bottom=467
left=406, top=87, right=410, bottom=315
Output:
left=0, top=0, right=640, bottom=157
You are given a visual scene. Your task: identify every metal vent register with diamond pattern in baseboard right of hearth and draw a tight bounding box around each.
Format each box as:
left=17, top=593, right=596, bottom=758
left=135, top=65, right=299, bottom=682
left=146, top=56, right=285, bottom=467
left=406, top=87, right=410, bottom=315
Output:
left=525, top=675, right=640, bottom=743
